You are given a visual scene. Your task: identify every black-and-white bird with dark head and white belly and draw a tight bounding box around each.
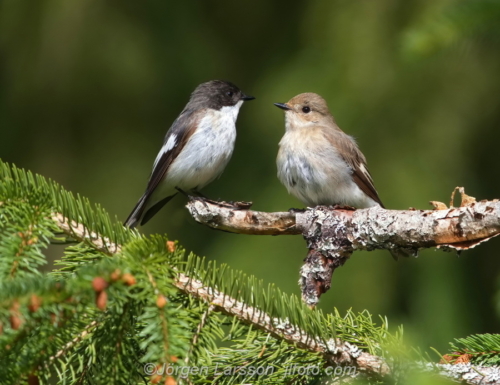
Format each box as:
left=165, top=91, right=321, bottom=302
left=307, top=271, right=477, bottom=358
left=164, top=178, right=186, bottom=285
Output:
left=125, top=80, right=254, bottom=227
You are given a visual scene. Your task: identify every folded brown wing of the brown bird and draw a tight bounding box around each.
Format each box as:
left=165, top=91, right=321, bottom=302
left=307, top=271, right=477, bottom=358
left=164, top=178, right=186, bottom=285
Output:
left=327, top=129, right=384, bottom=207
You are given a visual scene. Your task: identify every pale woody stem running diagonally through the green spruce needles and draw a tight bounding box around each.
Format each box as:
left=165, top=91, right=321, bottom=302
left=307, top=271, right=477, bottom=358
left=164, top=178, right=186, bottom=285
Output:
left=48, top=207, right=500, bottom=384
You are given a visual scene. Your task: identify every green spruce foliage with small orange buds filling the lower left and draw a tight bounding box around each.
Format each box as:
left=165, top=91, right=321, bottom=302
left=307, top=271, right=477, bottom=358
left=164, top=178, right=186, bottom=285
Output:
left=0, top=158, right=496, bottom=384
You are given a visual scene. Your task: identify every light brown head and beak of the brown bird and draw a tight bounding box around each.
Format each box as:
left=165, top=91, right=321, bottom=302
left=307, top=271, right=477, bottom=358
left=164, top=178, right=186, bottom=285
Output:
left=274, top=92, right=334, bottom=129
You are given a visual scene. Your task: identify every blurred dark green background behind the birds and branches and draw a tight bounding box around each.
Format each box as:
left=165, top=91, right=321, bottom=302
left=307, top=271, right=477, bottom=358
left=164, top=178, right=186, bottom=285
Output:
left=0, top=0, right=500, bottom=356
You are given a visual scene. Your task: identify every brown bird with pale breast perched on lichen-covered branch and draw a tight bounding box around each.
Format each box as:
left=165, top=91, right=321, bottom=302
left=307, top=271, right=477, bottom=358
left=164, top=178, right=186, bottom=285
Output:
left=275, top=92, right=405, bottom=255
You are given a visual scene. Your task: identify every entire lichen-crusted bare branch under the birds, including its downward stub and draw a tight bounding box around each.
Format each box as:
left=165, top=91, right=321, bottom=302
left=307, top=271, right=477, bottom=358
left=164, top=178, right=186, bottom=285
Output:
left=187, top=188, right=500, bottom=306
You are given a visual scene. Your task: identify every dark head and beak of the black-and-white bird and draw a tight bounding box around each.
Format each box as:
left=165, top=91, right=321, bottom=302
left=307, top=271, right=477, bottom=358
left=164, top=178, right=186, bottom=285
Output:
left=188, top=80, right=255, bottom=110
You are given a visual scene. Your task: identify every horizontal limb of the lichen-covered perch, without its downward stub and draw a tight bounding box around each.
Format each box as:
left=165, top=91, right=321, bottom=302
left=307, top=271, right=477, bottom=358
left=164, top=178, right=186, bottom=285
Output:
left=187, top=194, right=500, bottom=250
